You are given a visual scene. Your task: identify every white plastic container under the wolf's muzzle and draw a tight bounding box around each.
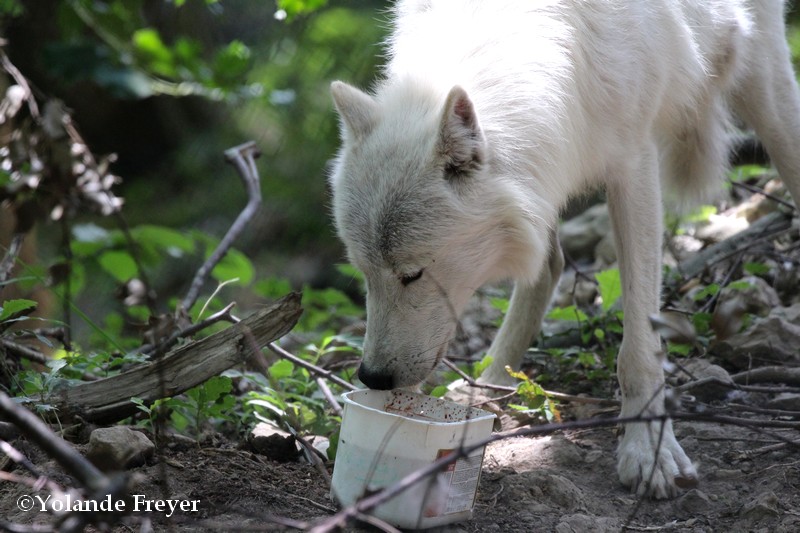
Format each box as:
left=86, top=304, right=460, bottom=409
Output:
left=331, top=390, right=495, bottom=529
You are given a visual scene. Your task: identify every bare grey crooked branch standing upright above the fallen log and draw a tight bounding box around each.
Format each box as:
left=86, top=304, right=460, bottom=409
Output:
left=180, top=142, right=261, bottom=311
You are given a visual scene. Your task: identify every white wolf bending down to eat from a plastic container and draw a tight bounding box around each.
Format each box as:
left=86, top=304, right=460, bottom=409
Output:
left=331, top=0, right=800, bottom=498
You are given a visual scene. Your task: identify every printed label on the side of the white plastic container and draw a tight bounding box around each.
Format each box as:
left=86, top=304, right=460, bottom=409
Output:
left=424, top=448, right=484, bottom=517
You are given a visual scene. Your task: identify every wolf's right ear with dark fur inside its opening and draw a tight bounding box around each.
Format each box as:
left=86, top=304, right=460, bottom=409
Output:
left=438, top=85, right=485, bottom=179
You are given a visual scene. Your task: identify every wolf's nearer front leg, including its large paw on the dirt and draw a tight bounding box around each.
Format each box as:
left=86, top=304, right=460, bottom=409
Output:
left=607, top=143, right=697, bottom=498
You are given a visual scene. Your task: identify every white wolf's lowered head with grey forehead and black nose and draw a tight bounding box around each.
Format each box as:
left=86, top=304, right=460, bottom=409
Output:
left=331, top=81, right=546, bottom=389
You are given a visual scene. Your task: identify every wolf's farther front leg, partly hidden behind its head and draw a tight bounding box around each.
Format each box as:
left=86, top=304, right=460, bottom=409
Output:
left=478, top=229, right=564, bottom=386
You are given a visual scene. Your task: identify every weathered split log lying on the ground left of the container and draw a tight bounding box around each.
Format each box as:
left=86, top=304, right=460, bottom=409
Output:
left=49, top=293, right=303, bottom=424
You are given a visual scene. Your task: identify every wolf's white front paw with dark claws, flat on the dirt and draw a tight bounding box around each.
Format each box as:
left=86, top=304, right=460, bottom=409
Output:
left=617, top=421, right=698, bottom=499
